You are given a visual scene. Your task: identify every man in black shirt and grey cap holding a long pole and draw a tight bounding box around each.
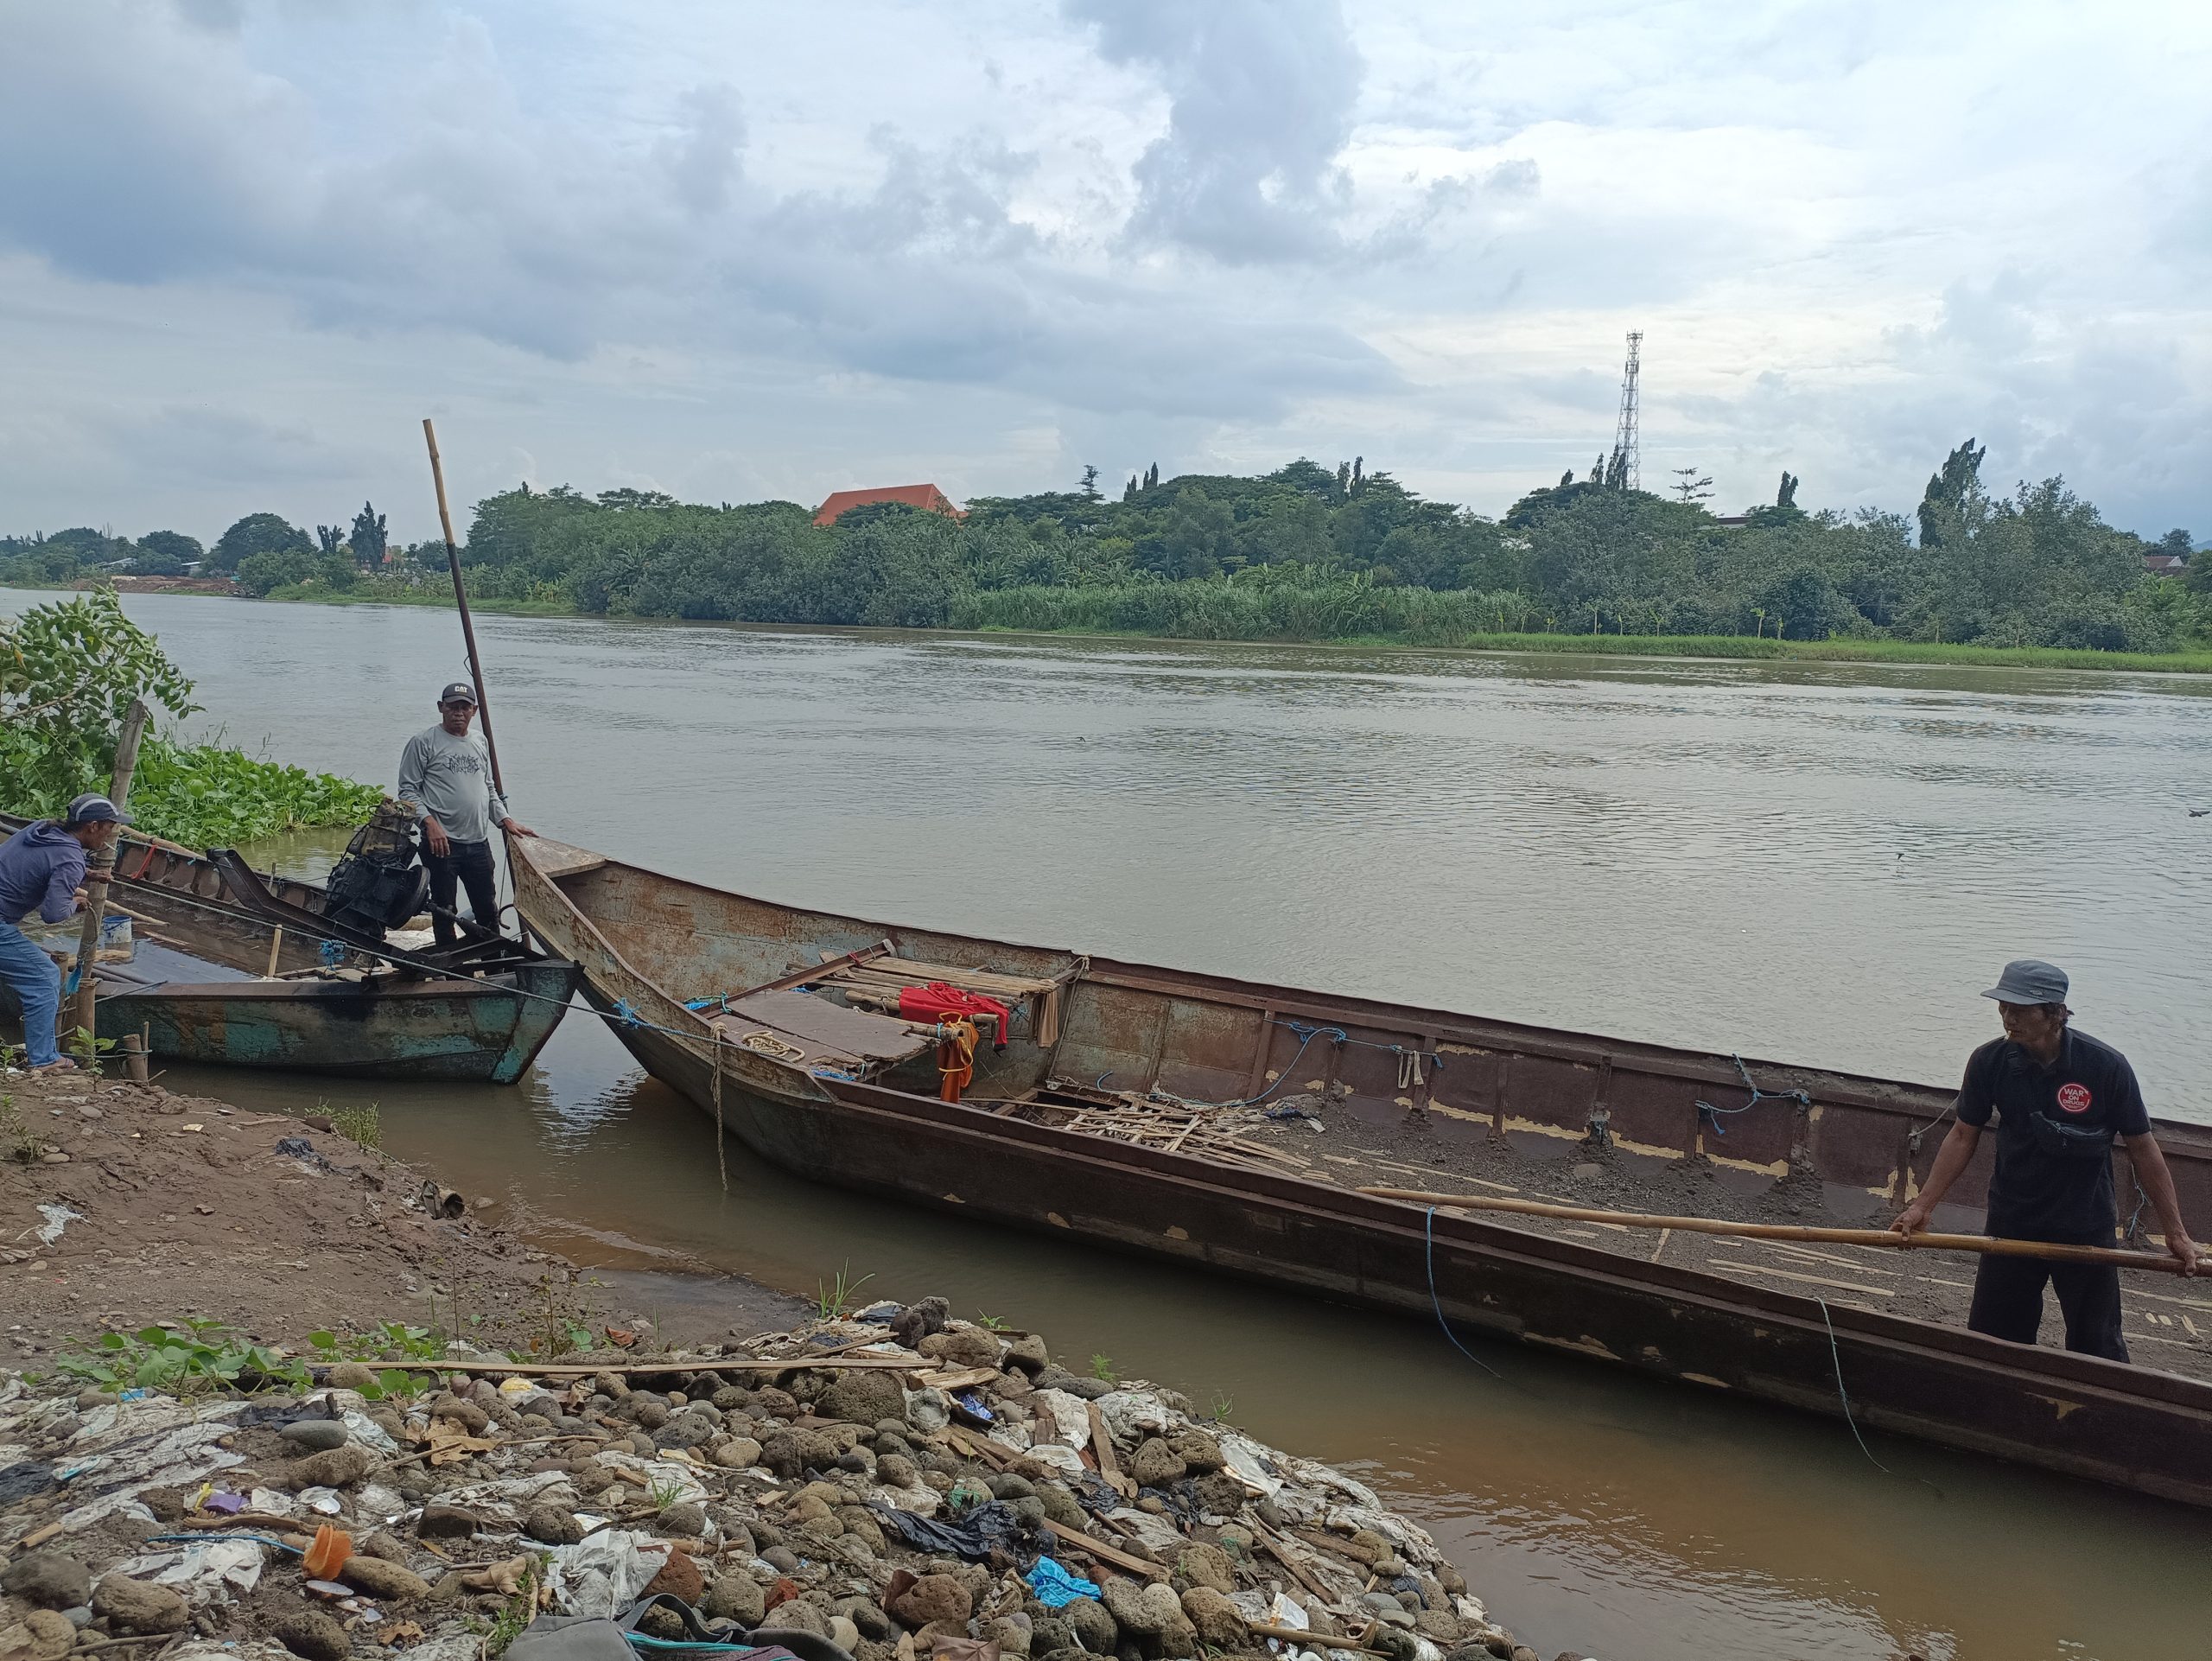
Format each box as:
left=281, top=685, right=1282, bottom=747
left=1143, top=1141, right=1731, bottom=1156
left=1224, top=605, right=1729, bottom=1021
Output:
left=1891, top=958, right=2199, bottom=1360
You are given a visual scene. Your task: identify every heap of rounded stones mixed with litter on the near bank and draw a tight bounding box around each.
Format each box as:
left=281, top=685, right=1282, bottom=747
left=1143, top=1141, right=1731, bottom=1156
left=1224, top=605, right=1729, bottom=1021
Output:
left=0, top=1298, right=1592, bottom=1661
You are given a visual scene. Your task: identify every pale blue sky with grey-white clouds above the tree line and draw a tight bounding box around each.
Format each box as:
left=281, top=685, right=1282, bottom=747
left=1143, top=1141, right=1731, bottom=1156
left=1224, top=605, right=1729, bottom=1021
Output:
left=0, top=0, right=2212, bottom=542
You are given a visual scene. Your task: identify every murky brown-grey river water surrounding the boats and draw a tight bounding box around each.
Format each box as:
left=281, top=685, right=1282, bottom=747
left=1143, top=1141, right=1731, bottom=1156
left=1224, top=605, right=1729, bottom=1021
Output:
left=0, top=595, right=2212, bottom=1661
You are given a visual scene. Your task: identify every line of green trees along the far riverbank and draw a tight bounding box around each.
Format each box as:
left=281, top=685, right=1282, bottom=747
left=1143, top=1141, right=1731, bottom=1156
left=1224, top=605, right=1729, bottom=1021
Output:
left=0, top=455, right=2212, bottom=650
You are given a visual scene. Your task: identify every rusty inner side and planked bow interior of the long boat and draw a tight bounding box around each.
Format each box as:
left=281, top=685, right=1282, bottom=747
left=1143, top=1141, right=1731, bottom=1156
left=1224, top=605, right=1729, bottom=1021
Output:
left=526, top=841, right=2212, bottom=1227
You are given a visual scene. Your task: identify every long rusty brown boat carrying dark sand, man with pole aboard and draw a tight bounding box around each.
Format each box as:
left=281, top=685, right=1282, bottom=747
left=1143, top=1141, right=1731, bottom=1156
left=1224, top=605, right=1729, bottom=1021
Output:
left=513, top=841, right=2212, bottom=1504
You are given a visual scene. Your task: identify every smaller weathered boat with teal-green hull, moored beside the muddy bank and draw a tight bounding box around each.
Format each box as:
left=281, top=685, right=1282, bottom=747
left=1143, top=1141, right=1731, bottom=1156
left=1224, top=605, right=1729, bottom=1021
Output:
left=0, top=816, right=580, bottom=1084
